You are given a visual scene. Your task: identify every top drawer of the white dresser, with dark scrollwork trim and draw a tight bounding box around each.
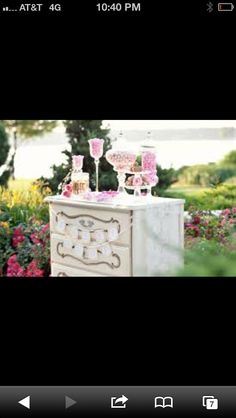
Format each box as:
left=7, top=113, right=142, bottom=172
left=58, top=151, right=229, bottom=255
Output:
left=50, top=204, right=131, bottom=245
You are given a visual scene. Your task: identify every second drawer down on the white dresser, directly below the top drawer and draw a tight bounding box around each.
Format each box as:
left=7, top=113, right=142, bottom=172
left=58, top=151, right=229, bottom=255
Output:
left=51, top=234, right=131, bottom=276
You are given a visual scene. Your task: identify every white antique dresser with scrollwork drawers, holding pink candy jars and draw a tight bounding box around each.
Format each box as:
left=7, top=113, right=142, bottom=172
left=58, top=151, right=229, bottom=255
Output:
left=46, top=196, right=184, bottom=277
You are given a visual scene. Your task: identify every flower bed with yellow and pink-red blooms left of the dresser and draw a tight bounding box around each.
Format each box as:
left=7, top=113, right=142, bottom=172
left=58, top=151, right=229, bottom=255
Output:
left=0, top=185, right=50, bottom=277
